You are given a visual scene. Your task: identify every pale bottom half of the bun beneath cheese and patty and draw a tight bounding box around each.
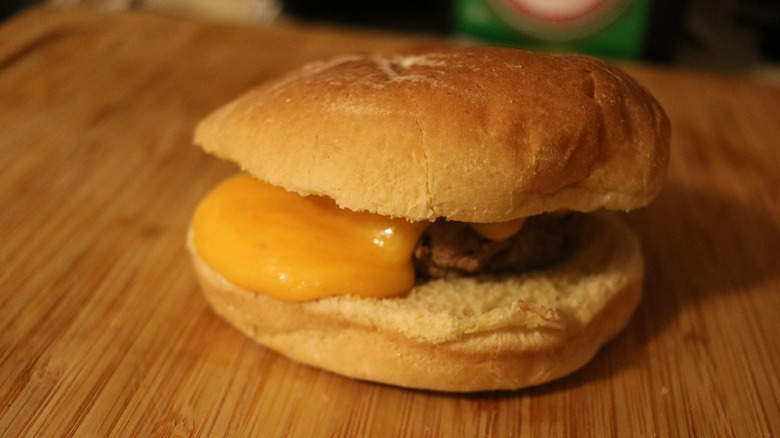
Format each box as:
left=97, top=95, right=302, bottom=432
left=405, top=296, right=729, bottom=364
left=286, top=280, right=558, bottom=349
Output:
left=189, top=212, right=644, bottom=392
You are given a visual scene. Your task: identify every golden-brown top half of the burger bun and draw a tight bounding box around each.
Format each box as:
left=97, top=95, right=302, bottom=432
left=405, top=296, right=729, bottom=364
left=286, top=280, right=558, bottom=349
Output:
left=195, top=47, right=670, bottom=222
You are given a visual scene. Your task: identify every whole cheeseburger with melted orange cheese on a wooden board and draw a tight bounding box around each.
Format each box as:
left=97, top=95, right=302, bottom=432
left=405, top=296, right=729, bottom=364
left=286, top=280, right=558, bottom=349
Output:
left=188, top=48, right=670, bottom=391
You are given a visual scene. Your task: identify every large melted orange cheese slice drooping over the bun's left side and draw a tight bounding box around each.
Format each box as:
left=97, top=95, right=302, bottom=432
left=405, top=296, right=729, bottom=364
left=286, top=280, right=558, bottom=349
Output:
left=192, top=174, right=428, bottom=301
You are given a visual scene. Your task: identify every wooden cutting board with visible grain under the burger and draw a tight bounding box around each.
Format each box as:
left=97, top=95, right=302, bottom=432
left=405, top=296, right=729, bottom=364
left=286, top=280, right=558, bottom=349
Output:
left=0, top=8, right=780, bottom=437
